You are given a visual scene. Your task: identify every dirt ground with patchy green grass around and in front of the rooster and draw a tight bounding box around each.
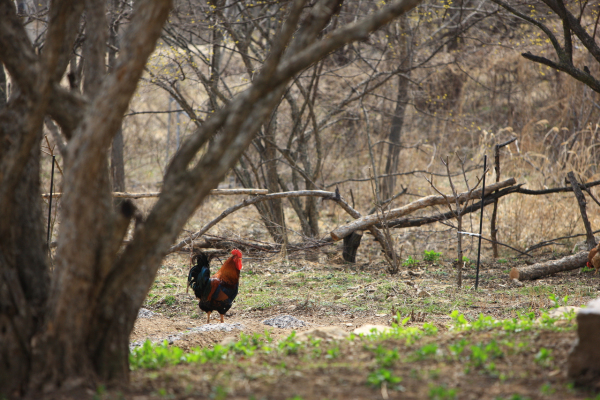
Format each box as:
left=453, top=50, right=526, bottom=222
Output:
left=113, top=254, right=600, bottom=400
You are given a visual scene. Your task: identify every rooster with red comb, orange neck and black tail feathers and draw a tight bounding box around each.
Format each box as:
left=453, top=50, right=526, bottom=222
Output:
left=188, top=249, right=242, bottom=324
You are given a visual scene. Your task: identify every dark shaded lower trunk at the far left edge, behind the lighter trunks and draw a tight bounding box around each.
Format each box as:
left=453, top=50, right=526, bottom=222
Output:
left=0, top=139, right=49, bottom=397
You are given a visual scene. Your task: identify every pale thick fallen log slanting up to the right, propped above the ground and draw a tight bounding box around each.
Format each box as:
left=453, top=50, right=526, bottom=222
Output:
left=331, top=178, right=516, bottom=241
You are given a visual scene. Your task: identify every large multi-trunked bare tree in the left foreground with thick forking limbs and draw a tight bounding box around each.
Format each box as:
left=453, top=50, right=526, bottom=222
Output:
left=0, top=0, right=418, bottom=397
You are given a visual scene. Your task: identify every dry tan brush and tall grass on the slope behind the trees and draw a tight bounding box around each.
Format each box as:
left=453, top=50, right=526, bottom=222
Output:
left=43, top=0, right=600, bottom=266
